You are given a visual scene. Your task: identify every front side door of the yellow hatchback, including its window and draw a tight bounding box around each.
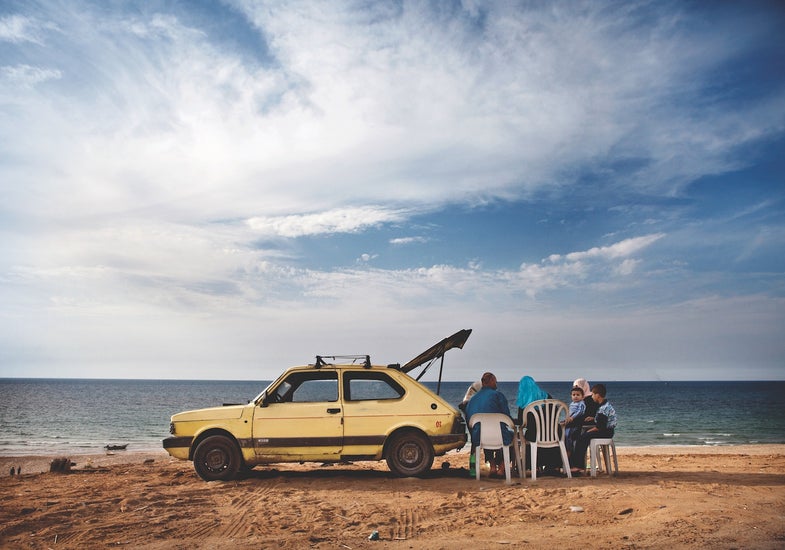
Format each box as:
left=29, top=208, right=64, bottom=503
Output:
left=253, top=368, right=343, bottom=462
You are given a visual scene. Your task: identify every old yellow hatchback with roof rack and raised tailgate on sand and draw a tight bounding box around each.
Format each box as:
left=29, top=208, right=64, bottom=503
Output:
left=163, top=329, right=471, bottom=481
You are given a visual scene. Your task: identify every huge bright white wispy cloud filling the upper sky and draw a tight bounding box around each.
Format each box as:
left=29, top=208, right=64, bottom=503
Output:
left=0, top=2, right=785, bottom=225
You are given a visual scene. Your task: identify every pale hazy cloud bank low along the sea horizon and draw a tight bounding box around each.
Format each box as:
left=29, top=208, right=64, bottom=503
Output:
left=0, top=256, right=785, bottom=380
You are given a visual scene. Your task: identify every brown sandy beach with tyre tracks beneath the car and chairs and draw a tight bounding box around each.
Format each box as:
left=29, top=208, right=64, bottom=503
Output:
left=0, top=445, right=785, bottom=550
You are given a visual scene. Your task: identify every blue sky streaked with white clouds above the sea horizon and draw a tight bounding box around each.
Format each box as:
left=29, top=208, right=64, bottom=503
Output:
left=0, top=0, right=785, bottom=381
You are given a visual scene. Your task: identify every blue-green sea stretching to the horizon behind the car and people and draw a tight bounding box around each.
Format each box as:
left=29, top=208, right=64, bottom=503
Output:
left=0, top=378, right=785, bottom=456
